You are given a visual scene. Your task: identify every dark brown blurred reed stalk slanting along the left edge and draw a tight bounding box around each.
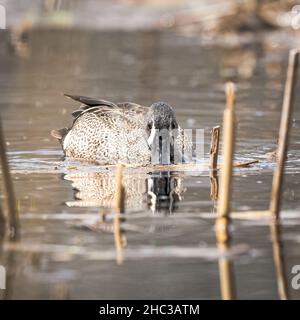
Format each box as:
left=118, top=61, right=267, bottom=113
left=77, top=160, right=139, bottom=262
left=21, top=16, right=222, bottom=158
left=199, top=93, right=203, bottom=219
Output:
left=0, top=116, right=20, bottom=240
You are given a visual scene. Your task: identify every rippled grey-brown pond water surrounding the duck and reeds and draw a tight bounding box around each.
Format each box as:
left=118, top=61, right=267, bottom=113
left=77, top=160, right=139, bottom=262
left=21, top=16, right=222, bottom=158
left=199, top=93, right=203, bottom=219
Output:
left=0, top=29, right=300, bottom=299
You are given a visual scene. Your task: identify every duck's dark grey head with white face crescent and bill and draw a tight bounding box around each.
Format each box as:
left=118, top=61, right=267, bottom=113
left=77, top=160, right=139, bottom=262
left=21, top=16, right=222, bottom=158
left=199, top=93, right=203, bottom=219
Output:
left=147, top=102, right=178, bottom=164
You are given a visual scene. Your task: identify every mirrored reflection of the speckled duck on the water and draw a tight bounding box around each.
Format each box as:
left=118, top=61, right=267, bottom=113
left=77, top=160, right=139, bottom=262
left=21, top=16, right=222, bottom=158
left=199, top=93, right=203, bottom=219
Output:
left=64, top=171, right=185, bottom=214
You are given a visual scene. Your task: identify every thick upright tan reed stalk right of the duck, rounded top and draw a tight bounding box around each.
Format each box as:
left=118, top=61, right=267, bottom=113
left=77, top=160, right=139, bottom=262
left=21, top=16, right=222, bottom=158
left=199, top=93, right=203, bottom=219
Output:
left=216, top=82, right=235, bottom=243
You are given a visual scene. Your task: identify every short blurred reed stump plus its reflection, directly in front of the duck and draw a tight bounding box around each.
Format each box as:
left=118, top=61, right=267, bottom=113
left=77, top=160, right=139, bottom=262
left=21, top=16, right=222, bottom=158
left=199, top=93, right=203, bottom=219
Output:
left=114, top=163, right=125, bottom=264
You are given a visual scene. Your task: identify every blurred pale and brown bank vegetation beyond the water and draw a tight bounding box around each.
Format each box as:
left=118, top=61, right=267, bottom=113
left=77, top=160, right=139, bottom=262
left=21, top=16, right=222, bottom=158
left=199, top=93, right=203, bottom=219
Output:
left=0, top=0, right=300, bottom=33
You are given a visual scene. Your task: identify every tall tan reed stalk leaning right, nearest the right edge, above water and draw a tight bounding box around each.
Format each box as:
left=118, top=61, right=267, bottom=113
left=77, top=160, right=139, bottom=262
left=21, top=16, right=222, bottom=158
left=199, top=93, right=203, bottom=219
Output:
left=270, top=49, right=300, bottom=219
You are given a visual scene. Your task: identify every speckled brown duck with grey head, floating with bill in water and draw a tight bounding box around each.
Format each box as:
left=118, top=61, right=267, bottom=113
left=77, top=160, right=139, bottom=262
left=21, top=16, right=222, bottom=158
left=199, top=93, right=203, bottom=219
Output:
left=51, top=94, right=192, bottom=165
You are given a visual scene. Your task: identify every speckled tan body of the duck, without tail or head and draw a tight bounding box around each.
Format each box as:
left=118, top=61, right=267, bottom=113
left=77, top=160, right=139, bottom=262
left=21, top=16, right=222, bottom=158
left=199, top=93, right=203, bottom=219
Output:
left=62, top=103, right=150, bottom=164
